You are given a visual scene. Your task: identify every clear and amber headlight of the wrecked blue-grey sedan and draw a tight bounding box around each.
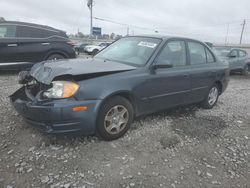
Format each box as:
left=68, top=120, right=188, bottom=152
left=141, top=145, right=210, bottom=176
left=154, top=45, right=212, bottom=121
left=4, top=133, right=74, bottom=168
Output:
left=43, top=81, right=79, bottom=99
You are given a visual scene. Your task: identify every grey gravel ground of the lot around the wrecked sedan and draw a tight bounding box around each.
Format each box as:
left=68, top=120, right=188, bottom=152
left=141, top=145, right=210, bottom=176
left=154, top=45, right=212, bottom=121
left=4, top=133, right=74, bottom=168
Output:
left=0, top=73, right=250, bottom=188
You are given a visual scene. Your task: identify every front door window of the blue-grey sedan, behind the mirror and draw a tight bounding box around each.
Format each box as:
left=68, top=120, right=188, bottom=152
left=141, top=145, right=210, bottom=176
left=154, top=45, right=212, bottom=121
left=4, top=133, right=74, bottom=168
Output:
left=157, top=41, right=186, bottom=67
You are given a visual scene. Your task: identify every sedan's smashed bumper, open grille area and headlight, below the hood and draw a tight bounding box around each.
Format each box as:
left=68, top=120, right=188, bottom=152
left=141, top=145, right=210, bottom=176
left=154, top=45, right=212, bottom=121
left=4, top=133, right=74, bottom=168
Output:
left=10, top=68, right=101, bottom=135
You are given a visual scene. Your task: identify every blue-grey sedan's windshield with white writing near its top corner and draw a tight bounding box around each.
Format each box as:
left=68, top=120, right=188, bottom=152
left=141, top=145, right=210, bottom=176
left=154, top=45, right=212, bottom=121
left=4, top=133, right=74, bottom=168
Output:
left=95, top=37, right=161, bottom=67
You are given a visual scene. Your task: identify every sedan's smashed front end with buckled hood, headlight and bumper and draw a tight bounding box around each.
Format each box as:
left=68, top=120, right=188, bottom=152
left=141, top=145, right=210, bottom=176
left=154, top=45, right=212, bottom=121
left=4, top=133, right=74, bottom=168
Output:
left=10, top=59, right=135, bottom=135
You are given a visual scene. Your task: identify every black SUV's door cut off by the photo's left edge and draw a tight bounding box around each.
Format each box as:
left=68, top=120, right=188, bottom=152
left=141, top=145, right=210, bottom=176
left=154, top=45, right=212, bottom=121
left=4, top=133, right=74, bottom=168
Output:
left=0, top=24, right=19, bottom=64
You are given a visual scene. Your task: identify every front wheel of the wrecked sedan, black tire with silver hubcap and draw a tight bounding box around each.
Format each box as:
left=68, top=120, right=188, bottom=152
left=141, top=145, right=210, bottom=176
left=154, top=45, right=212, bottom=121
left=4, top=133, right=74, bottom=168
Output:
left=96, top=96, right=134, bottom=141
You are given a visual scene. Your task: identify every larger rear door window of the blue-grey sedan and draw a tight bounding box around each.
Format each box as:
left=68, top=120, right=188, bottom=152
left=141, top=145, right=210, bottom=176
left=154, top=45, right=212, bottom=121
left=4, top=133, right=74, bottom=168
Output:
left=188, top=42, right=207, bottom=65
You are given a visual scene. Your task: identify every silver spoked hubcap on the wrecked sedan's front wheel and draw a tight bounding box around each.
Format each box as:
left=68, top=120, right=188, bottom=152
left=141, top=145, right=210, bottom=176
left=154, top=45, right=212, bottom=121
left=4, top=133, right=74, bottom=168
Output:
left=104, top=105, right=129, bottom=134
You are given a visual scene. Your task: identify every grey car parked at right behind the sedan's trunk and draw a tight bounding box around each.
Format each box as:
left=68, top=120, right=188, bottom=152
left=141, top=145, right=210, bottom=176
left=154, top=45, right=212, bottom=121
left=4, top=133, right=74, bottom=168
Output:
left=214, top=47, right=250, bottom=75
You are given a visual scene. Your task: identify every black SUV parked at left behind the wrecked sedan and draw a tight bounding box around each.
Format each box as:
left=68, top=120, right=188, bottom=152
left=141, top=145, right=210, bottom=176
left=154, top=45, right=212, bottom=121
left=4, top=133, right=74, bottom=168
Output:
left=0, top=21, right=75, bottom=69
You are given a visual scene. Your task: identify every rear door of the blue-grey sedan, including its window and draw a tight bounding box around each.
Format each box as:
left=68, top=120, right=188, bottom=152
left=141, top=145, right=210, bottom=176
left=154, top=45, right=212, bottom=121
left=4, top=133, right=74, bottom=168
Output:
left=187, top=41, right=216, bottom=102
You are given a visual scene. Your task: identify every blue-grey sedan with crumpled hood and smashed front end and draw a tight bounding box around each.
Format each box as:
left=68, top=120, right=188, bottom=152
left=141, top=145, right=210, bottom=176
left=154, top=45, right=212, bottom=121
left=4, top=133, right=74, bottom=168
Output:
left=10, top=36, right=229, bottom=140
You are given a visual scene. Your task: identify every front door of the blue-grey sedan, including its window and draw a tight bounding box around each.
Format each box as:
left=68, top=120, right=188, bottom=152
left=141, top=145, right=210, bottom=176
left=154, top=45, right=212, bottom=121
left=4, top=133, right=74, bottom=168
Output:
left=142, top=40, right=190, bottom=111
